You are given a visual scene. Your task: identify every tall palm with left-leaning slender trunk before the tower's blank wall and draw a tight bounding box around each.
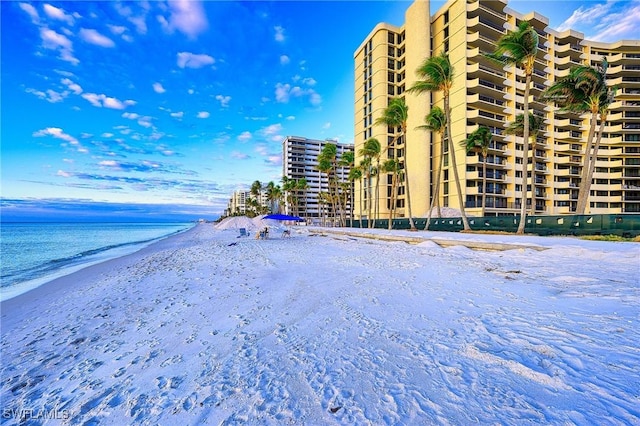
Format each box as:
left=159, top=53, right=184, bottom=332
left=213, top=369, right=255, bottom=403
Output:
left=408, top=52, right=471, bottom=231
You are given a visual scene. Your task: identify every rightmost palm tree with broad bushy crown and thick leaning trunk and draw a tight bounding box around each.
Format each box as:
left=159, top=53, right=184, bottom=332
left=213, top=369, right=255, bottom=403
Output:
left=543, top=59, right=616, bottom=214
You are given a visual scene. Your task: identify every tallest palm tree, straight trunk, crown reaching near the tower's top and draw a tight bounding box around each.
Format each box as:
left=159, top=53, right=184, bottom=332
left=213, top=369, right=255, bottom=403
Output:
left=487, top=21, right=538, bottom=234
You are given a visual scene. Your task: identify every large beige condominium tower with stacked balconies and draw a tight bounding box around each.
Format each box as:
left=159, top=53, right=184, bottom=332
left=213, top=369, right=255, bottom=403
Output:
left=354, top=0, right=640, bottom=218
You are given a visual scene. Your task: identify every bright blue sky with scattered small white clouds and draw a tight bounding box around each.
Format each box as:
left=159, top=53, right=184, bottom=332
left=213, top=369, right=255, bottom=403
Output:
left=0, top=1, right=640, bottom=220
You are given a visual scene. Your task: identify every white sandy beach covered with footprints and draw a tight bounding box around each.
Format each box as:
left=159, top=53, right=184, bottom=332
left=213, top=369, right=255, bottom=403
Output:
left=0, top=224, right=640, bottom=426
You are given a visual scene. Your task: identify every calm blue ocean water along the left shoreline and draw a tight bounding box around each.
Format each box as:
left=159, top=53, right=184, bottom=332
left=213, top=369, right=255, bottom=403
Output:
left=0, top=223, right=193, bottom=300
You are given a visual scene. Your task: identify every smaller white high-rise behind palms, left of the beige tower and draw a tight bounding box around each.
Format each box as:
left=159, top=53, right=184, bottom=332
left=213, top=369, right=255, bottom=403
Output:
left=282, top=136, right=353, bottom=224
